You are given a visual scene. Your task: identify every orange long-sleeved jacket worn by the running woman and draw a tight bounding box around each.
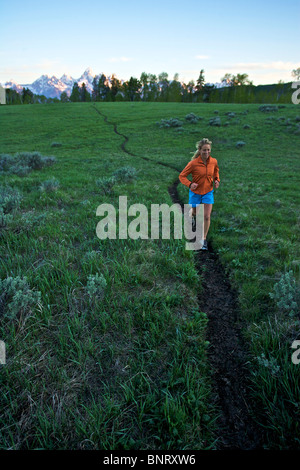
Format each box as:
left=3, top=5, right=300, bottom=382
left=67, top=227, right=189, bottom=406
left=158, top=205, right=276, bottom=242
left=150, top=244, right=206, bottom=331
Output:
left=179, top=155, right=220, bottom=195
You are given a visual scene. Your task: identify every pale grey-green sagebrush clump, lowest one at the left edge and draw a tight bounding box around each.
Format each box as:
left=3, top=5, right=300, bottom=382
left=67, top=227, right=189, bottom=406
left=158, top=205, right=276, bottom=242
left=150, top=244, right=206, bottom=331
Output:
left=0, top=276, right=41, bottom=319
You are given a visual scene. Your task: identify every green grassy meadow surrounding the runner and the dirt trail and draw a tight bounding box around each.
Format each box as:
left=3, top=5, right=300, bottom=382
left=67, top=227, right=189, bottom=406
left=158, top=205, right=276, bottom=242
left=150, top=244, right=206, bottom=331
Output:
left=0, top=102, right=300, bottom=450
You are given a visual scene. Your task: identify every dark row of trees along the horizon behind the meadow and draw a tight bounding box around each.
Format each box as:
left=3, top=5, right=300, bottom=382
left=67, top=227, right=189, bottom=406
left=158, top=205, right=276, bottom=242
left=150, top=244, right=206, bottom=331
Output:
left=6, top=69, right=295, bottom=104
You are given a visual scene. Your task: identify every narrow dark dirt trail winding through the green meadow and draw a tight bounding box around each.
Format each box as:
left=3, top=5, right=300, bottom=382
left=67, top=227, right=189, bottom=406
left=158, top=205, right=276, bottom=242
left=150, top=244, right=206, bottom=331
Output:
left=94, top=107, right=263, bottom=450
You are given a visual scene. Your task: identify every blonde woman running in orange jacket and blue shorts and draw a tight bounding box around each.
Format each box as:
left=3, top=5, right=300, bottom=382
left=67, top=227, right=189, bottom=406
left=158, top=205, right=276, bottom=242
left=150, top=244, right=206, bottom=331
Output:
left=179, top=139, right=220, bottom=250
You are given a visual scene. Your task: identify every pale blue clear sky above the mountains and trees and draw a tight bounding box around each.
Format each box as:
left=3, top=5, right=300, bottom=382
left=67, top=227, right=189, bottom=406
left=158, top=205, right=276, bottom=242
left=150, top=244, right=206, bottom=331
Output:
left=0, top=0, right=300, bottom=85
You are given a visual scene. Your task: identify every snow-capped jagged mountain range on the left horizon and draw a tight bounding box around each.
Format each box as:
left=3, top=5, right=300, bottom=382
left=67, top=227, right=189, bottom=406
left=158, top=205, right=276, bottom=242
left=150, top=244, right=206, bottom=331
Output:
left=3, top=68, right=100, bottom=98
